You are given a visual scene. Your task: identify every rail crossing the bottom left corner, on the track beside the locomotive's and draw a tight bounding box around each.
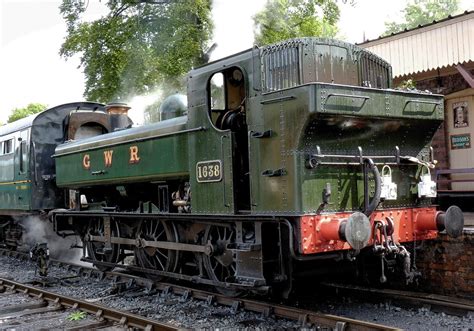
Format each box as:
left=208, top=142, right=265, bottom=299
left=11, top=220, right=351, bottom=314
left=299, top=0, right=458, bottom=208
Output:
left=0, top=278, right=179, bottom=330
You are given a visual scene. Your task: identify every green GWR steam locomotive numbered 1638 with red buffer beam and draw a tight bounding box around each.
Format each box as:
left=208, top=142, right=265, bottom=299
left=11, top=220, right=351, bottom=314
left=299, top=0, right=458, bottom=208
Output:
left=52, top=38, right=463, bottom=295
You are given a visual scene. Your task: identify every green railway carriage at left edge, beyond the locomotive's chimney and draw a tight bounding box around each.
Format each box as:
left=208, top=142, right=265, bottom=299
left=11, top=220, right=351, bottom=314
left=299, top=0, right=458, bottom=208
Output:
left=0, top=102, right=126, bottom=247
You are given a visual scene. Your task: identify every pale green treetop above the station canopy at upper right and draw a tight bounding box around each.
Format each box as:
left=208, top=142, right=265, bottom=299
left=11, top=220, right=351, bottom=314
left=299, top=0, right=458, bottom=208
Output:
left=383, top=0, right=459, bottom=36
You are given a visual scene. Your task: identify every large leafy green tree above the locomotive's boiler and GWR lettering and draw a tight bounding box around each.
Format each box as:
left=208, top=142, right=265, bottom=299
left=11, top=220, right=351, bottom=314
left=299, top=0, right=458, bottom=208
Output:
left=60, top=0, right=213, bottom=102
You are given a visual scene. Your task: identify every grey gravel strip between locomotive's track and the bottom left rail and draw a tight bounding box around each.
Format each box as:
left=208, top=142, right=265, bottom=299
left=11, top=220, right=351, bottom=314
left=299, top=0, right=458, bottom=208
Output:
left=0, top=256, right=299, bottom=330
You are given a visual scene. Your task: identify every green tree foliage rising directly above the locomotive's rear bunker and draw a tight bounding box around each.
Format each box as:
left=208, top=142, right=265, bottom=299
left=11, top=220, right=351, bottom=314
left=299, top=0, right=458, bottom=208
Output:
left=253, top=0, right=340, bottom=45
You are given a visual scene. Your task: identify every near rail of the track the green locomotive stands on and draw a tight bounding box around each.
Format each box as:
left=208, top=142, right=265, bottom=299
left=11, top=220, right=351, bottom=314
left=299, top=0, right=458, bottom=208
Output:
left=0, top=249, right=399, bottom=331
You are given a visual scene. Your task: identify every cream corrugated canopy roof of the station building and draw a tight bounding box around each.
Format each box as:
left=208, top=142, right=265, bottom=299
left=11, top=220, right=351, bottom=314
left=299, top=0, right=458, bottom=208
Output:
left=359, top=11, right=474, bottom=77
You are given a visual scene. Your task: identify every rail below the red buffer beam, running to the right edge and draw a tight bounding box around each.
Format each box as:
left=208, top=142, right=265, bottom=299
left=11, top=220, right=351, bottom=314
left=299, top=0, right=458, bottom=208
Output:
left=321, top=283, right=474, bottom=316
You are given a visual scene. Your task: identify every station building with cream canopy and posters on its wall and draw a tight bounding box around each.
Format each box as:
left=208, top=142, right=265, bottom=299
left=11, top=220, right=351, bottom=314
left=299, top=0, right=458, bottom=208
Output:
left=359, top=11, right=474, bottom=199
